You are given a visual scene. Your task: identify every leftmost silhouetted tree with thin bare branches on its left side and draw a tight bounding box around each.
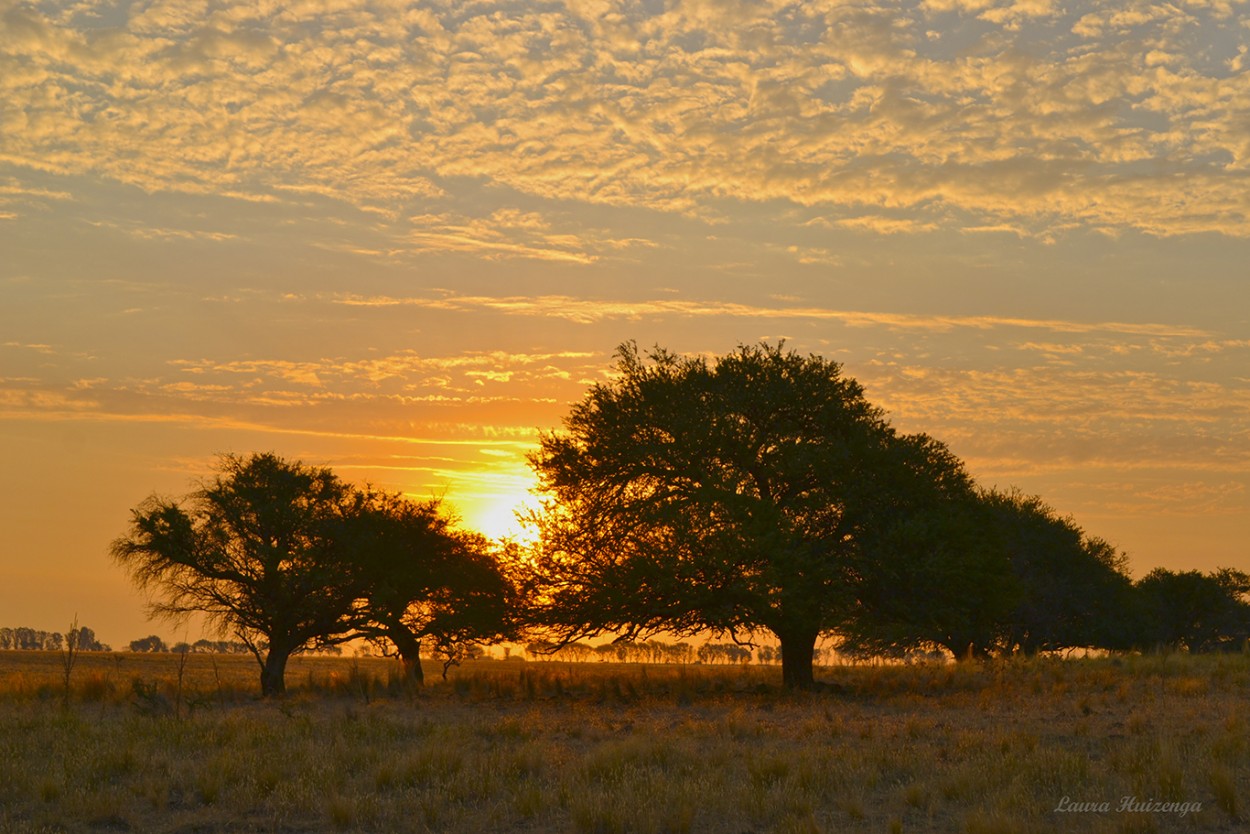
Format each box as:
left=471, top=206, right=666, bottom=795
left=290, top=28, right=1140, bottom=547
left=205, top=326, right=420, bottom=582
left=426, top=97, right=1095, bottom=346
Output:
left=113, top=454, right=359, bottom=696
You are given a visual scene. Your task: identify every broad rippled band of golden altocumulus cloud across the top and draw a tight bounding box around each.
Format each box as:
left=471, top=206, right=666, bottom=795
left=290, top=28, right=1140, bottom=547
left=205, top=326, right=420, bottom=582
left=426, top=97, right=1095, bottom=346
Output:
left=0, top=0, right=1250, bottom=236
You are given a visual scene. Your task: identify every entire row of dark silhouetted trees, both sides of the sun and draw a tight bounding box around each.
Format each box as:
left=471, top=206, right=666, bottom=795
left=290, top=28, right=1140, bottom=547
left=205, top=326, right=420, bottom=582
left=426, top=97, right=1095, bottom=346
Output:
left=113, top=344, right=1250, bottom=695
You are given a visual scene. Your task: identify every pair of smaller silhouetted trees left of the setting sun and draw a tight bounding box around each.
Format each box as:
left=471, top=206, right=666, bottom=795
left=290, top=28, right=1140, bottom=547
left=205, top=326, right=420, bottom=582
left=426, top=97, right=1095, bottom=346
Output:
left=113, top=453, right=516, bottom=696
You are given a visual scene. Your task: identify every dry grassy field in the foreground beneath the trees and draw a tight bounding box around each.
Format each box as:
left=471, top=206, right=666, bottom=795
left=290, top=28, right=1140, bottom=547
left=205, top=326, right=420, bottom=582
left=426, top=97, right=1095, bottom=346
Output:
left=0, top=653, right=1250, bottom=834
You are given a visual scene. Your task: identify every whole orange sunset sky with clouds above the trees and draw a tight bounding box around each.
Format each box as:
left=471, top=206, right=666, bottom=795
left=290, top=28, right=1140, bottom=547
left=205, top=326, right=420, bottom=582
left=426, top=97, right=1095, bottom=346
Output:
left=0, top=0, right=1250, bottom=646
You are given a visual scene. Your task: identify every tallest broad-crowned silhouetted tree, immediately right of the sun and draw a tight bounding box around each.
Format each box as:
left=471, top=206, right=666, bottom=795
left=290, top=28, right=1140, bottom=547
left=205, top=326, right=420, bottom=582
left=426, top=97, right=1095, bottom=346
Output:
left=531, top=344, right=970, bottom=686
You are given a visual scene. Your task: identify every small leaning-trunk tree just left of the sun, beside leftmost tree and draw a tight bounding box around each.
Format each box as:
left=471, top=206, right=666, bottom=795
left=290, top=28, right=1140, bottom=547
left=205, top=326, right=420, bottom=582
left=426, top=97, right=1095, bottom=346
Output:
left=349, top=491, right=521, bottom=685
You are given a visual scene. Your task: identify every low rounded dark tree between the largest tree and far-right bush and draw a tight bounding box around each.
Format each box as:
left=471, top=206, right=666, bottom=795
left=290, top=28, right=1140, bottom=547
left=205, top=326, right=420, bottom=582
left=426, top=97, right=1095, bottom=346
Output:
left=840, top=490, right=1131, bottom=659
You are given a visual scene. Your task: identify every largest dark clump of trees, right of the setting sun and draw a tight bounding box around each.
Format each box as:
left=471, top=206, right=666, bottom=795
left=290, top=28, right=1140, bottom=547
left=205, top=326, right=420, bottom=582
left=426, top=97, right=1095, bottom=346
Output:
left=531, top=344, right=1250, bottom=686
